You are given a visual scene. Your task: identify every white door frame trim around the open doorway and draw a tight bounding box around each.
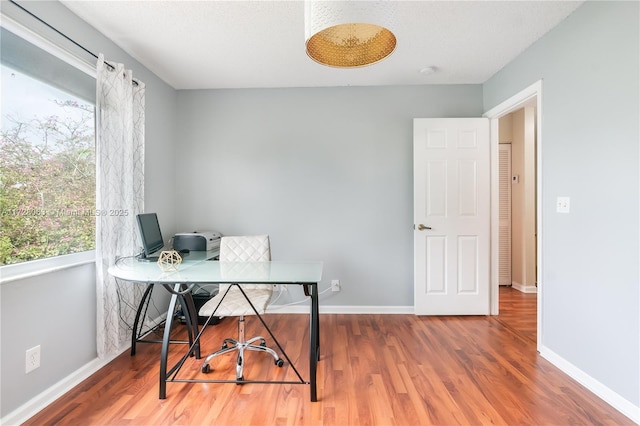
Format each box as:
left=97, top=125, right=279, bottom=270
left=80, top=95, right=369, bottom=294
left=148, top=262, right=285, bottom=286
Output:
left=482, top=80, right=544, bottom=352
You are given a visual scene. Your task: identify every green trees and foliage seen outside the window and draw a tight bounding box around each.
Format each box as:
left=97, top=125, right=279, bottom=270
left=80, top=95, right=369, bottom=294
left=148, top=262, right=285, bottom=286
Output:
left=0, top=100, right=96, bottom=265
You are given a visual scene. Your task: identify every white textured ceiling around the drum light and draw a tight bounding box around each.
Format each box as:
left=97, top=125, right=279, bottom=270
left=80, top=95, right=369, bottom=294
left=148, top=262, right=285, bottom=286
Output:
left=61, top=0, right=582, bottom=89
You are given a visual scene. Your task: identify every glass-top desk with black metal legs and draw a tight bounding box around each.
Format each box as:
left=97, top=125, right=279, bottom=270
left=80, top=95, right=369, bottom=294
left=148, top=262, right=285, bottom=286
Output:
left=109, top=252, right=323, bottom=402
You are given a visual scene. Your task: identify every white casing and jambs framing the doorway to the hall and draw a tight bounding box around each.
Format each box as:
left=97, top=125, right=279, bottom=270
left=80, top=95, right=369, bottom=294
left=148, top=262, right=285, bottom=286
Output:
left=484, top=80, right=544, bottom=350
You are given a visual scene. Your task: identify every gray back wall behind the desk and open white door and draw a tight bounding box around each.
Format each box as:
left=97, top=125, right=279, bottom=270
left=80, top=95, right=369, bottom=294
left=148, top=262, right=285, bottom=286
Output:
left=176, top=85, right=482, bottom=308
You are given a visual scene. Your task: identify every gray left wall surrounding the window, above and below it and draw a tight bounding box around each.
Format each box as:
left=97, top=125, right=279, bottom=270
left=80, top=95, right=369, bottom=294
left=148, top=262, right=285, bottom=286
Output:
left=0, top=0, right=176, bottom=417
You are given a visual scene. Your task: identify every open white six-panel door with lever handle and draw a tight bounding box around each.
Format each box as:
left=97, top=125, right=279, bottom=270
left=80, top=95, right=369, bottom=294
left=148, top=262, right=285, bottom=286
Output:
left=413, top=118, right=491, bottom=315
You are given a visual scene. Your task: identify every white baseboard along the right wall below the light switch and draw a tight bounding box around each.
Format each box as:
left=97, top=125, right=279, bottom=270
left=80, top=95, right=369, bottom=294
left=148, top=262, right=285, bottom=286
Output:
left=540, top=346, right=640, bottom=424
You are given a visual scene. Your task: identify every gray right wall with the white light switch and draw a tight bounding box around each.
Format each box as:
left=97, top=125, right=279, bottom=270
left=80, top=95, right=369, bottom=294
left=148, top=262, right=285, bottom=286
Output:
left=484, top=2, right=640, bottom=407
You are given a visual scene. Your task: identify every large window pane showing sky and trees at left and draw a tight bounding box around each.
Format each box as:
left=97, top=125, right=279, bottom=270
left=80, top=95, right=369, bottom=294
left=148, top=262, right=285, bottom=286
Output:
left=0, top=28, right=96, bottom=265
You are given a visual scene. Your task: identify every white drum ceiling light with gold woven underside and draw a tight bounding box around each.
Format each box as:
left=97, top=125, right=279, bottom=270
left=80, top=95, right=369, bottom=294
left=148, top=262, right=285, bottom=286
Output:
left=305, top=0, right=396, bottom=68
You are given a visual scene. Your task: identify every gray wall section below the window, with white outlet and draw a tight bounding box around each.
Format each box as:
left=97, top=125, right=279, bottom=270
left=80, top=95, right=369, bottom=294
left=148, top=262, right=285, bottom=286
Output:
left=0, top=264, right=96, bottom=416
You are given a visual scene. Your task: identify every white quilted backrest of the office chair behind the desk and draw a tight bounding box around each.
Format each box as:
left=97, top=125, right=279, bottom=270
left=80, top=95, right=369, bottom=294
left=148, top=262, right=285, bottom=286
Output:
left=219, top=235, right=273, bottom=292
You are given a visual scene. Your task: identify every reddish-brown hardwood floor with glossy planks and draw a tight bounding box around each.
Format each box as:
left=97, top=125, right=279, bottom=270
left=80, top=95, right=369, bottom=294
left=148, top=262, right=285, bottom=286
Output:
left=25, top=288, right=634, bottom=425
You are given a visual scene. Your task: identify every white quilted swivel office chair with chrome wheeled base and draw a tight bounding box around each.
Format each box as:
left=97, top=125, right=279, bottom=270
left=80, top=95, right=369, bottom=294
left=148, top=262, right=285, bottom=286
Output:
left=199, top=235, right=284, bottom=382
